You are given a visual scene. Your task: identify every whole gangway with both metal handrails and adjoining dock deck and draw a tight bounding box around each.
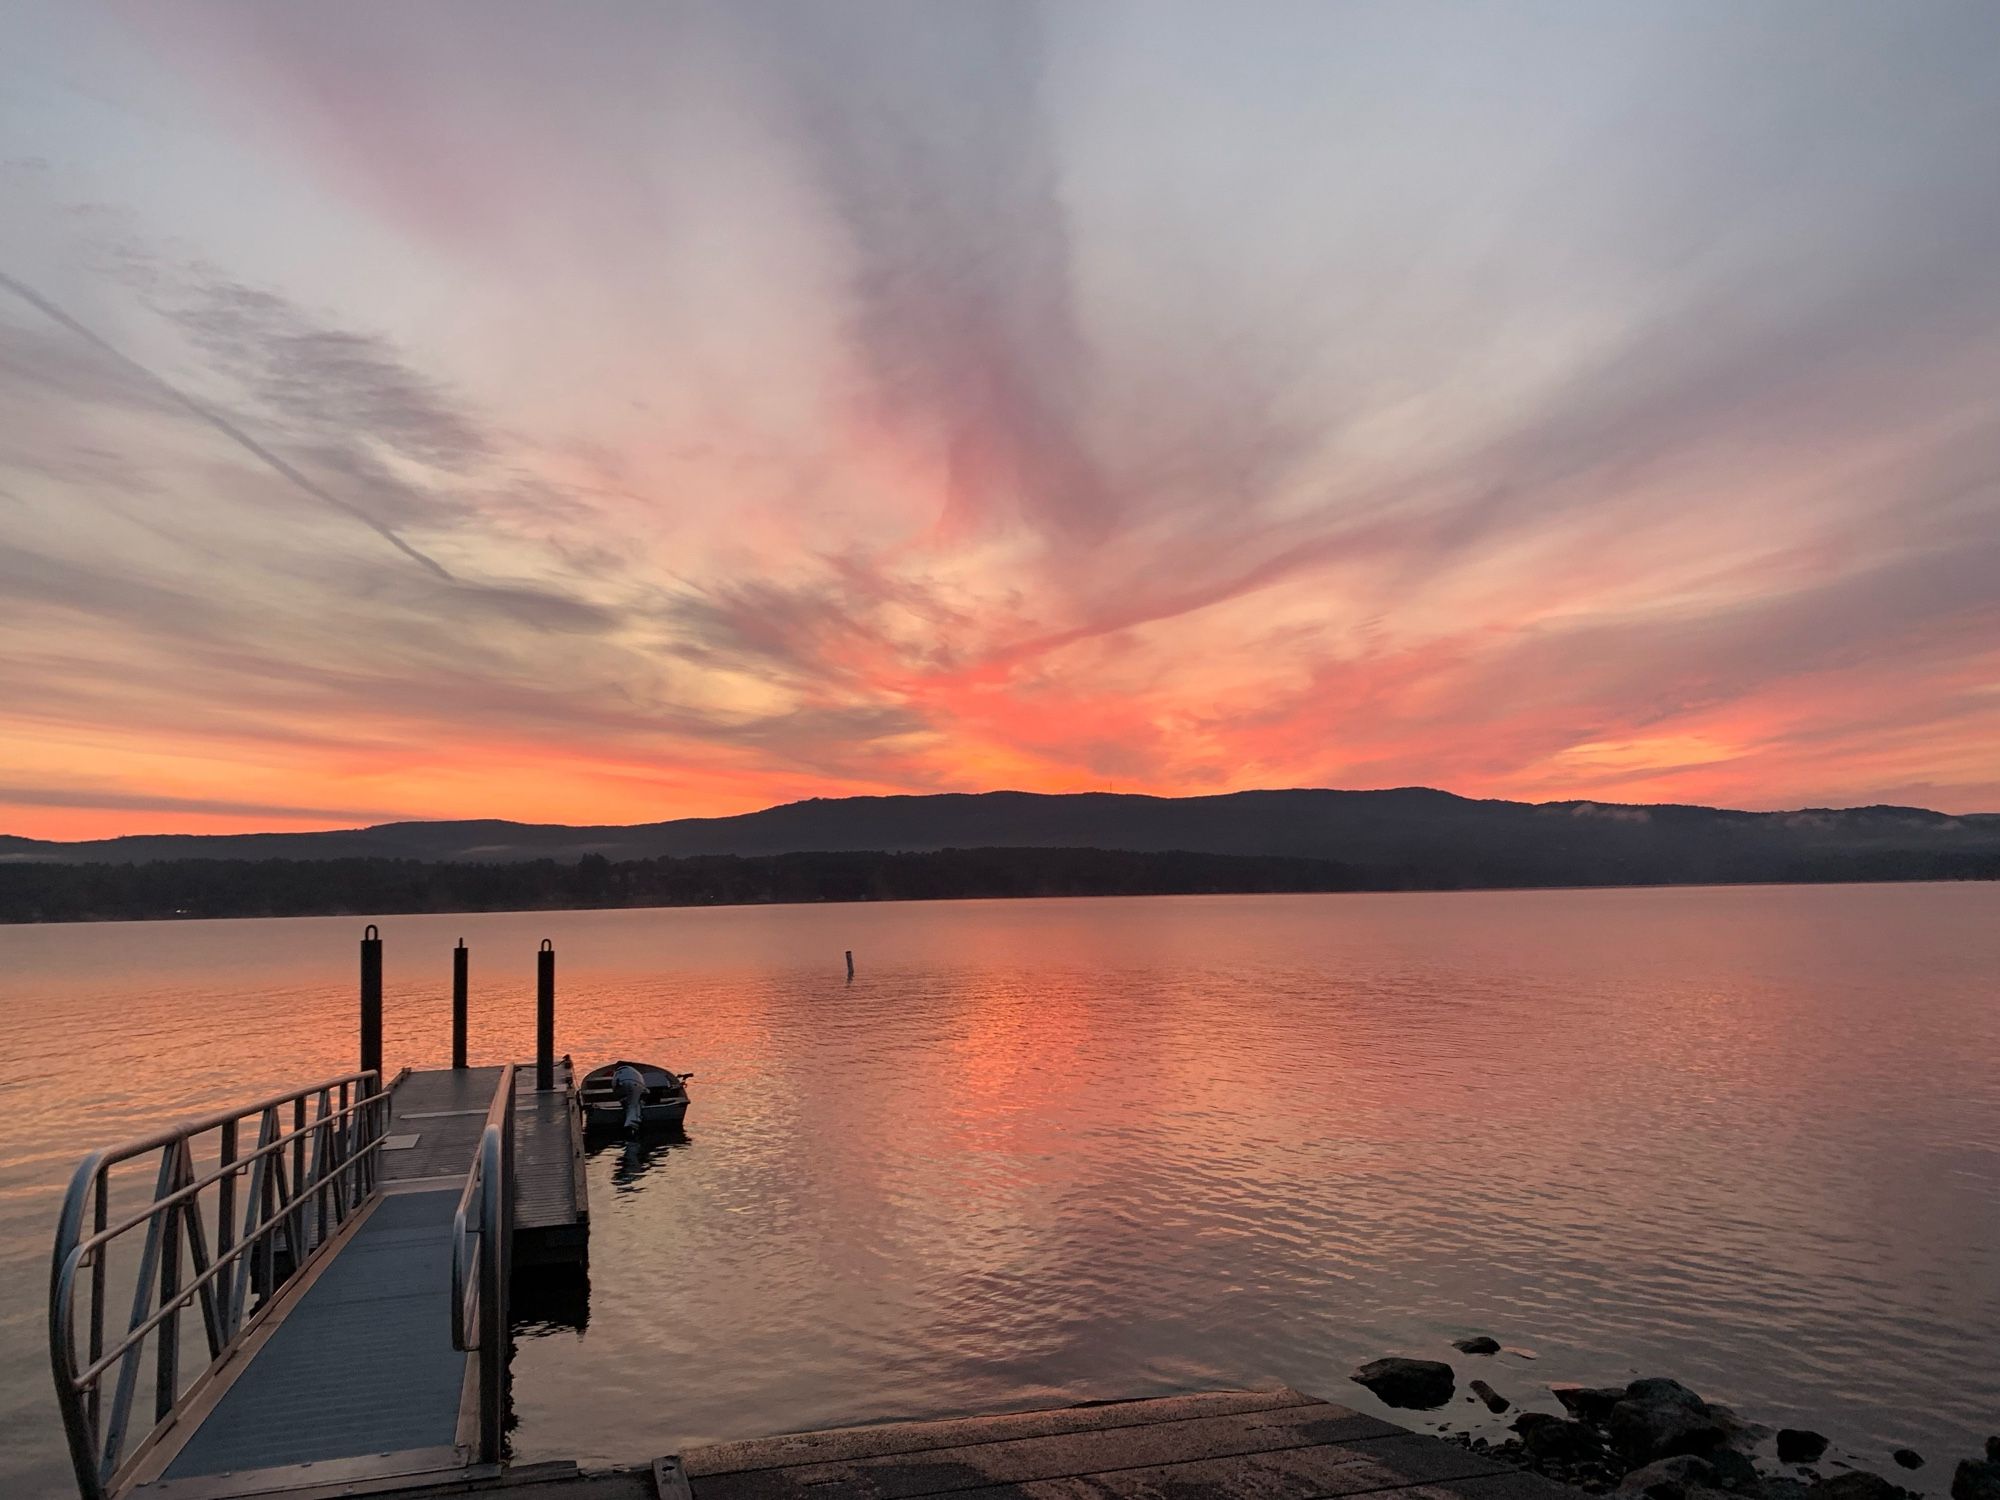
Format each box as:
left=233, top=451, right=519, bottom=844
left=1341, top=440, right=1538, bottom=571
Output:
left=50, top=1060, right=586, bottom=1500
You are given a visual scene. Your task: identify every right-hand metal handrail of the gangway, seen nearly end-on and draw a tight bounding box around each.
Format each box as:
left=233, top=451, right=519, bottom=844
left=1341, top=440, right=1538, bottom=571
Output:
left=452, top=1068, right=514, bottom=1464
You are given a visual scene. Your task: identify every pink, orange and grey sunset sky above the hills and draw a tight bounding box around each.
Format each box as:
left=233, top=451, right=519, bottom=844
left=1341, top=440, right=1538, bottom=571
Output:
left=0, top=0, right=2000, bottom=838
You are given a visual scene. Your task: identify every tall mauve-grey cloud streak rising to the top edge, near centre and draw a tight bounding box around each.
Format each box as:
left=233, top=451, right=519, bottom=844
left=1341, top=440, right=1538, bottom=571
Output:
left=738, top=4, right=1120, bottom=542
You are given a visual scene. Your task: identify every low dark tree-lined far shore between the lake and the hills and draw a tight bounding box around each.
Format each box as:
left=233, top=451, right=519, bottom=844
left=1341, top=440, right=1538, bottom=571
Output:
left=0, top=848, right=2000, bottom=926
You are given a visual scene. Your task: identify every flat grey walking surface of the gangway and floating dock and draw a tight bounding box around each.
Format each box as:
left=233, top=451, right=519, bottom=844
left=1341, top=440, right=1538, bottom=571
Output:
left=136, top=1062, right=588, bottom=1500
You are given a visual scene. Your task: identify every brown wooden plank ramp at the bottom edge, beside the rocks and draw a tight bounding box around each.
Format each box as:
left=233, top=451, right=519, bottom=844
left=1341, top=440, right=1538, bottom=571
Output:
left=234, top=1390, right=1578, bottom=1500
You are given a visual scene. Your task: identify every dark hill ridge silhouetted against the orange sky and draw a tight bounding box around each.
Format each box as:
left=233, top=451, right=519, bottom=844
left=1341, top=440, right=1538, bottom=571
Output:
left=0, top=788, right=2000, bottom=888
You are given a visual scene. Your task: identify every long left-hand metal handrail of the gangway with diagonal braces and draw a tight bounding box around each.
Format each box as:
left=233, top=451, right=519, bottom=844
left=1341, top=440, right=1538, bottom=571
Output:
left=48, top=1072, right=388, bottom=1500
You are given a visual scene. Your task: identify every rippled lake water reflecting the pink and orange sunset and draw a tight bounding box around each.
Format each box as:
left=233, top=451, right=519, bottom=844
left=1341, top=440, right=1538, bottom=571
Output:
left=0, top=884, right=2000, bottom=1496
